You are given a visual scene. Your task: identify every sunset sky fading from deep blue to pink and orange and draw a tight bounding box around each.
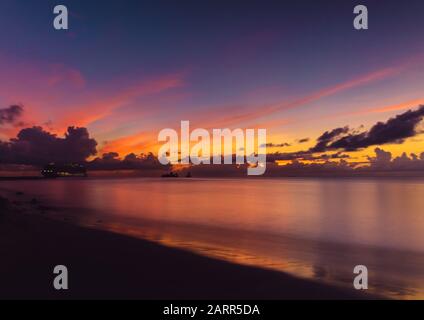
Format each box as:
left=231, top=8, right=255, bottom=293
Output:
left=0, top=0, right=424, bottom=162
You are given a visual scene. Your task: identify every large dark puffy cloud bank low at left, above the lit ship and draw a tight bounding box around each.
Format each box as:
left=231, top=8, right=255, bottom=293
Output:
left=0, top=127, right=97, bottom=165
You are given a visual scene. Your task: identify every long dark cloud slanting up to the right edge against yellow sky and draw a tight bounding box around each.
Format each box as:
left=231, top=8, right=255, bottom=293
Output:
left=309, top=106, right=424, bottom=152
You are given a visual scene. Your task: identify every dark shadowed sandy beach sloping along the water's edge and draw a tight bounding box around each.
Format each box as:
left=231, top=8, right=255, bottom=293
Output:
left=0, top=192, right=371, bottom=299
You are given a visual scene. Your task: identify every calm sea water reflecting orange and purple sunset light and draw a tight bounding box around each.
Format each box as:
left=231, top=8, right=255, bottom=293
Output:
left=0, top=179, right=424, bottom=298
